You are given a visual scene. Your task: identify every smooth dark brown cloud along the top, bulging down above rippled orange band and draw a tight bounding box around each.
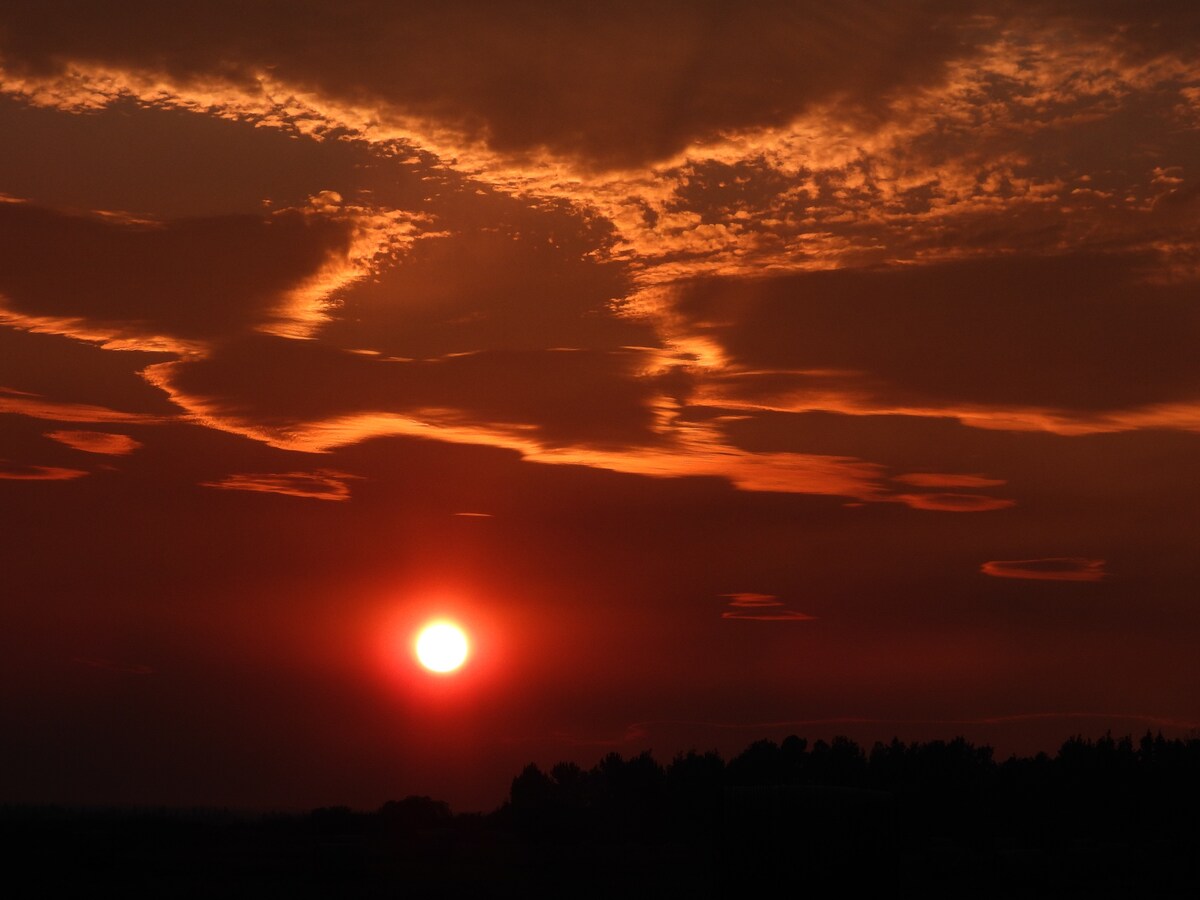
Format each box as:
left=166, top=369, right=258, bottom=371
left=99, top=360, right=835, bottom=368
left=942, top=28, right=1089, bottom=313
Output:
left=0, top=0, right=971, bottom=168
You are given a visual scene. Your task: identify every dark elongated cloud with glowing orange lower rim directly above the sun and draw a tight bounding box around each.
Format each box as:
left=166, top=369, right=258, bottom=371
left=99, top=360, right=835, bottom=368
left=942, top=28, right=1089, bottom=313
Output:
left=138, top=336, right=907, bottom=500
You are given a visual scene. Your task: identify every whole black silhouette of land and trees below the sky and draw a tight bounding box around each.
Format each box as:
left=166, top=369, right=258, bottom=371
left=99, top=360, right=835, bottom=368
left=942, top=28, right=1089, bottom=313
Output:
left=0, top=732, right=1200, bottom=898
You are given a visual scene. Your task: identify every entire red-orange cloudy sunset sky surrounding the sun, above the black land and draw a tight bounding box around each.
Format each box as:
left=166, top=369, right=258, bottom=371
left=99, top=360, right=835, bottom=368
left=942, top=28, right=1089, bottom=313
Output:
left=0, top=0, right=1200, bottom=810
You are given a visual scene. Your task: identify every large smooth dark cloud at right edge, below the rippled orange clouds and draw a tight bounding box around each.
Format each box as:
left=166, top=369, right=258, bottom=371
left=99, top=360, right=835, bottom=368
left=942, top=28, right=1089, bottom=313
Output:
left=664, top=254, right=1200, bottom=421
